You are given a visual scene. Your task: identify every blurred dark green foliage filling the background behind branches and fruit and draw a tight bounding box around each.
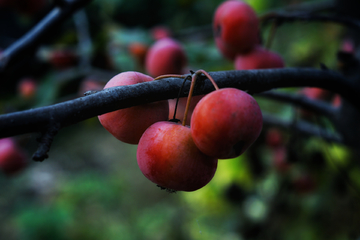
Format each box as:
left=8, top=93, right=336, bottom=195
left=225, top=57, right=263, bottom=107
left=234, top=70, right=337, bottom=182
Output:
left=0, top=0, right=360, bottom=240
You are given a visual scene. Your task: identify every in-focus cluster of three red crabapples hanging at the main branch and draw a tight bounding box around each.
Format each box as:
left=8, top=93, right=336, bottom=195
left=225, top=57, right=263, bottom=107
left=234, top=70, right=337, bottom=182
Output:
left=99, top=72, right=262, bottom=191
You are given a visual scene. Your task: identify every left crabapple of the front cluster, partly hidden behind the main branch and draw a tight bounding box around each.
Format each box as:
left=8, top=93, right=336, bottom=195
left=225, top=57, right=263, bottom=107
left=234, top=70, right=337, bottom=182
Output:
left=99, top=72, right=169, bottom=144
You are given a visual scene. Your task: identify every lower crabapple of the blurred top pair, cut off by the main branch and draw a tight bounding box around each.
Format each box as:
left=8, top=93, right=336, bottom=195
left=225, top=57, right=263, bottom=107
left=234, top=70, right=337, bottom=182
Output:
left=234, top=46, right=285, bottom=70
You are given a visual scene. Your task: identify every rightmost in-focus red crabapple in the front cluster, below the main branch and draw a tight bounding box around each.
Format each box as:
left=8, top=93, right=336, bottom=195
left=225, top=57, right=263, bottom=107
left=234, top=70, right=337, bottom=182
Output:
left=190, top=88, right=262, bottom=159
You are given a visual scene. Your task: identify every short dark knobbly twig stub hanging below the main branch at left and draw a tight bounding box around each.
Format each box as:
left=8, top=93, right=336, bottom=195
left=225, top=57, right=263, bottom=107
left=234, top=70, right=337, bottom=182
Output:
left=32, top=123, right=61, bottom=162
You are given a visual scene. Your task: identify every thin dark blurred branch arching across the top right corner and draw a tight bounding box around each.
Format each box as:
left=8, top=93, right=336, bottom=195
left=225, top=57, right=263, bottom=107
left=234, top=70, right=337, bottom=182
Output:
left=260, top=12, right=360, bottom=31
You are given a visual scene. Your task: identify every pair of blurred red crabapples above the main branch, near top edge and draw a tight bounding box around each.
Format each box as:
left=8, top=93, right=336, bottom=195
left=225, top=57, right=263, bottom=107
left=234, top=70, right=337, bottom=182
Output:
left=213, top=0, right=284, bottom=70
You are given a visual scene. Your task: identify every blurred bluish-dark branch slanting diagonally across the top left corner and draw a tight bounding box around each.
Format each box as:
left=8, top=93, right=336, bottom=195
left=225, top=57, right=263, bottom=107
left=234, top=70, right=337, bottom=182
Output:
left=0, top=0, right=91, bottom=73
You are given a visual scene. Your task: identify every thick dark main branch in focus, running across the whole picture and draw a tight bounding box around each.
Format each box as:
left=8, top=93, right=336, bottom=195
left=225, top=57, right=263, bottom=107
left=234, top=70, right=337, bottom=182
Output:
left=0, top=68, right=360, bottom=138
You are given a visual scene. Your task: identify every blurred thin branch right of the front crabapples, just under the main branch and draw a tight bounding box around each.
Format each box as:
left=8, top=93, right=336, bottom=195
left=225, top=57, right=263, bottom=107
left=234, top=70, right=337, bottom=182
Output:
left=259, top=91, right=337, bottom=118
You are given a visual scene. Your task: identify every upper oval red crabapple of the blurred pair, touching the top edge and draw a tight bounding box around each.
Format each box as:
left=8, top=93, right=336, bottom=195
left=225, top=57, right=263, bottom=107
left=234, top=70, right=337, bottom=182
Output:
left=213, top=0, right=259, bottom=60
